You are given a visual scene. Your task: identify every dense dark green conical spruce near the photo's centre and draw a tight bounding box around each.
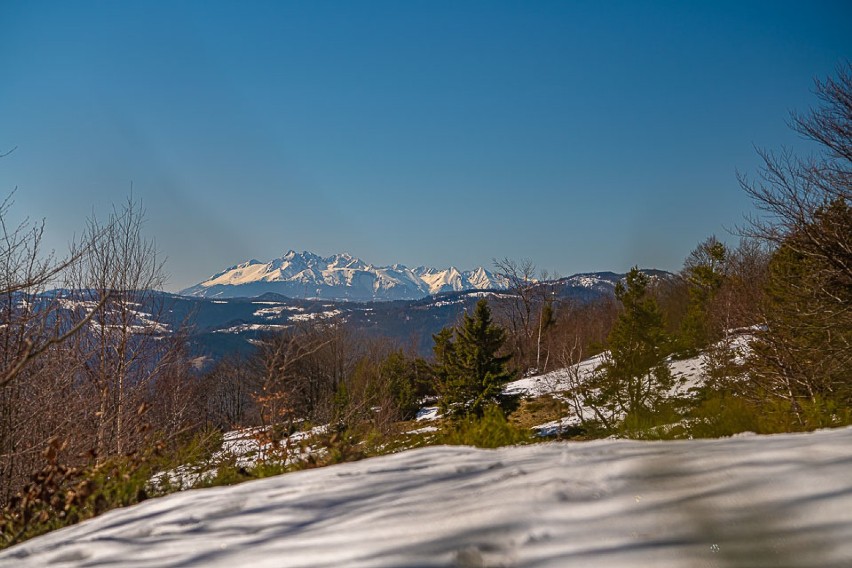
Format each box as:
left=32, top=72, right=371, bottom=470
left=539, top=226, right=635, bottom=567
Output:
left=433, top=298, right=514, bottom=416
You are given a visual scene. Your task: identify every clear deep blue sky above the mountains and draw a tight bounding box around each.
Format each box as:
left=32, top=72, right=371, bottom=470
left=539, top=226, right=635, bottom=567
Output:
left=0, top=0, right=852, bottom=290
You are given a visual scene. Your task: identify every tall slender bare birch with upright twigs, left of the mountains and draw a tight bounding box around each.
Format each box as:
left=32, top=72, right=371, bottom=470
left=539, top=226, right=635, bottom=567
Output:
left=66, top=196, right=170, bottom=456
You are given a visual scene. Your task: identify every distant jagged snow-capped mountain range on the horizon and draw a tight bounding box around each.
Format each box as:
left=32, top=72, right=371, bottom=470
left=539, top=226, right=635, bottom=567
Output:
left=180, top=250, right=508, bottom=301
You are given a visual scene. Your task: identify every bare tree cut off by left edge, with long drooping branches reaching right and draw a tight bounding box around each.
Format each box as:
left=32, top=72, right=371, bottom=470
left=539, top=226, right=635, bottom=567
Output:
left=0, top=196, right=108, bottom=503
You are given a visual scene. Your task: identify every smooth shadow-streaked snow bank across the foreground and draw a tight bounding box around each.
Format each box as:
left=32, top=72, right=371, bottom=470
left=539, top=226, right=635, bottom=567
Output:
left=0, top=428, right=852, bottom=568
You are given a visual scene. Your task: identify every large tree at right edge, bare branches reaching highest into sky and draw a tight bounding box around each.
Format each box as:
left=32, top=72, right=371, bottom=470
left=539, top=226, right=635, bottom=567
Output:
left=740, top=63, right=852, bottom=418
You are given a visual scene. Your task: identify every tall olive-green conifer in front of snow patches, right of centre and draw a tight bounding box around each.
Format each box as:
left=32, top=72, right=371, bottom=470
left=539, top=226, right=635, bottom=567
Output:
left=584, top=267, right=674, bottom=428
